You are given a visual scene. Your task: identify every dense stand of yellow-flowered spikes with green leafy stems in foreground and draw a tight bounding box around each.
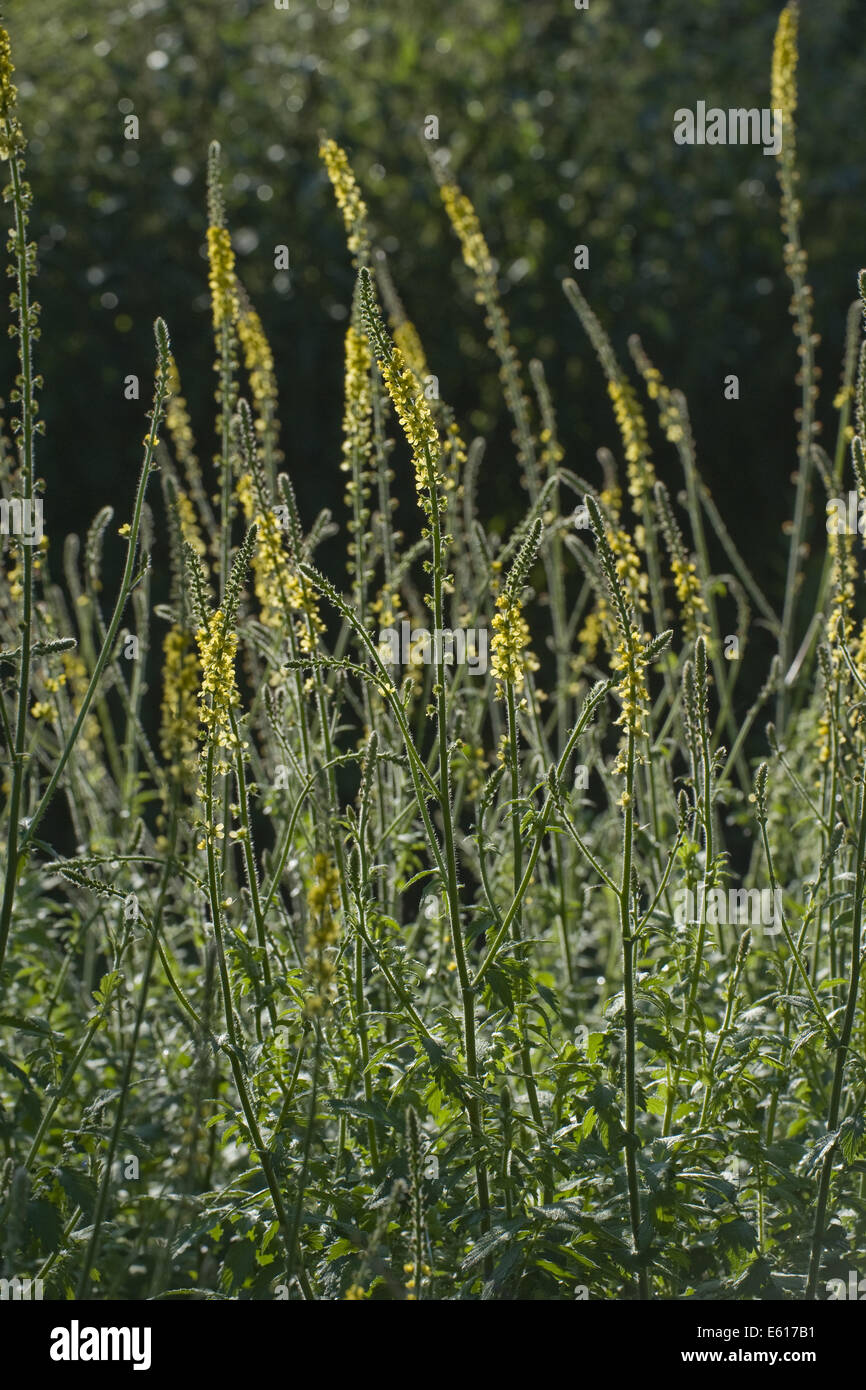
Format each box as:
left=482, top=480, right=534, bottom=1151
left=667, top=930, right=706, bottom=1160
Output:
left=0, top=6, right=866, bottom=1300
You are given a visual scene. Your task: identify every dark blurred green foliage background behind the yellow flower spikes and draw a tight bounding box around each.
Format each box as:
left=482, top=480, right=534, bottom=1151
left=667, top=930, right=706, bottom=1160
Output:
left=0, top=0, right=866, bottom=614
